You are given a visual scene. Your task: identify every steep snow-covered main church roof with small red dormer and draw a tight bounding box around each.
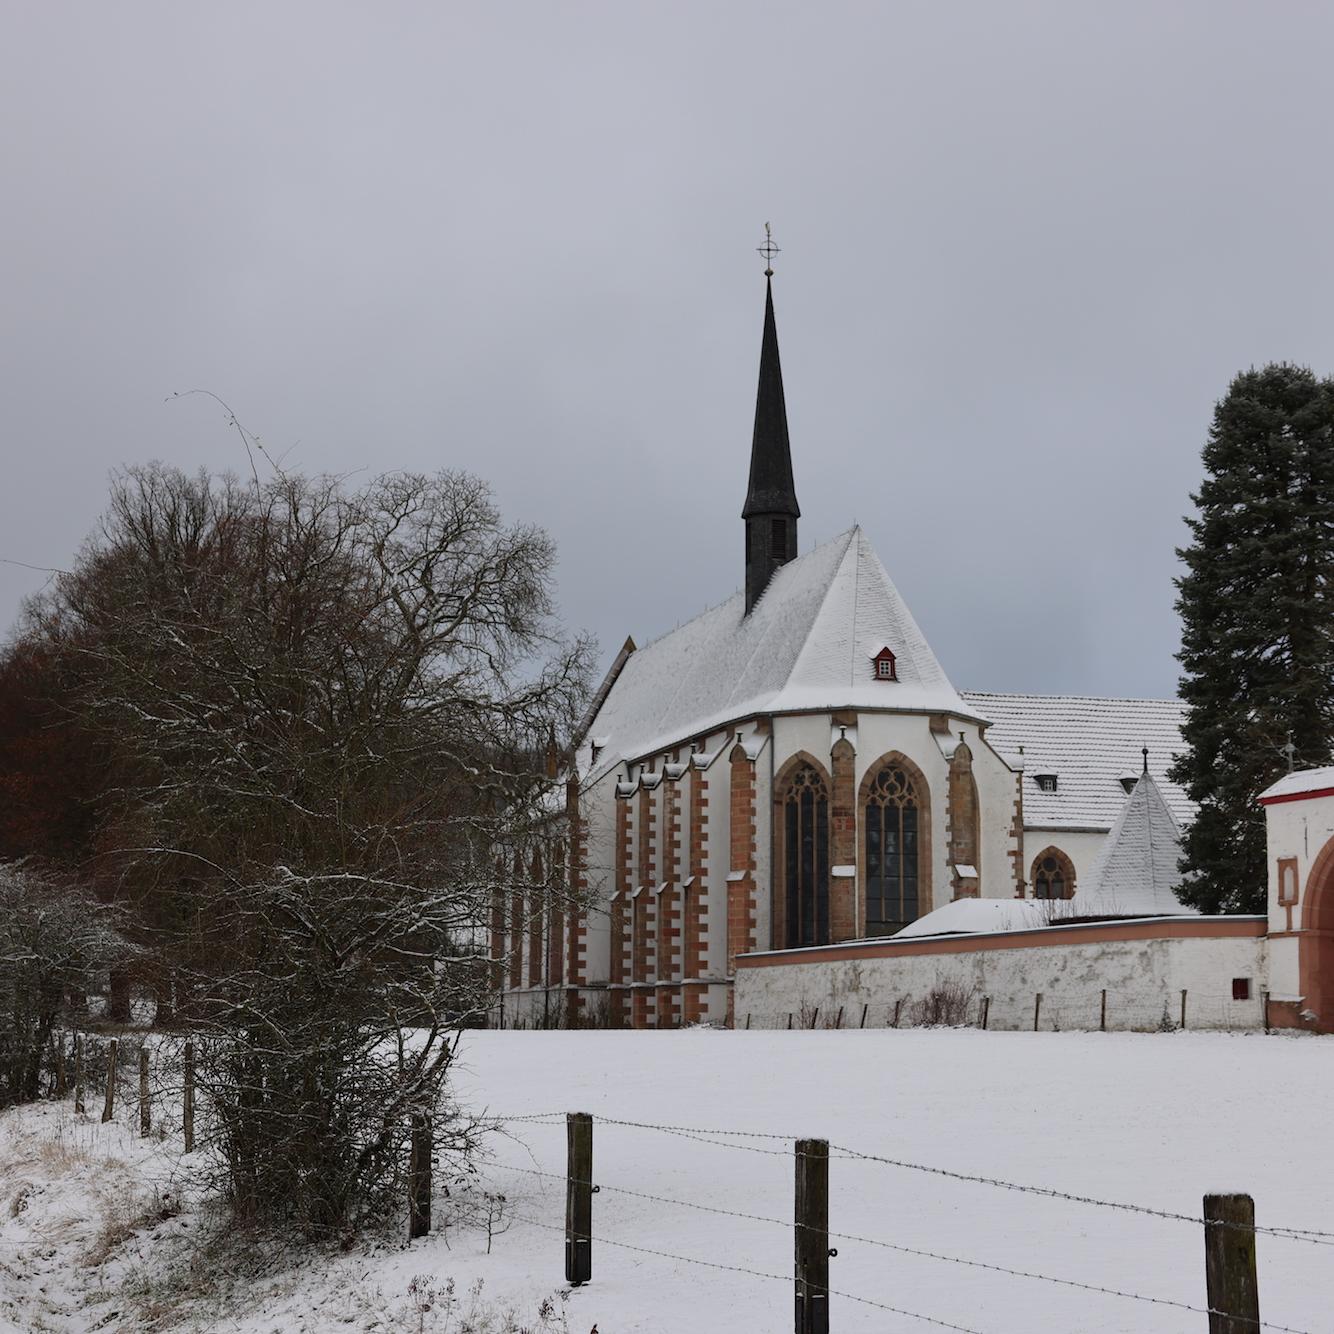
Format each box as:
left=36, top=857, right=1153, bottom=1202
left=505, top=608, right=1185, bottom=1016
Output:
left=579, top=527, right=979, bottom=776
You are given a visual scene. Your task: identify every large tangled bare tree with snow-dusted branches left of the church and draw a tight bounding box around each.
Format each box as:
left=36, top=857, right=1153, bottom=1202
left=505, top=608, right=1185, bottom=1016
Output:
left=23, top=466, right=588, bottom=1235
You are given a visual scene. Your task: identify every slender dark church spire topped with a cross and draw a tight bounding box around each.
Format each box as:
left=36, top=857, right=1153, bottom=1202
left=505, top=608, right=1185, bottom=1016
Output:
left=742, top=223, right=802, bottom=615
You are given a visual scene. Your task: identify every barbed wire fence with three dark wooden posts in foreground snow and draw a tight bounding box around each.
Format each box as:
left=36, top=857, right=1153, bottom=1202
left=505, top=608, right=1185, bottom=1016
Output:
left=491, top=1111, right=1334, bottom=1334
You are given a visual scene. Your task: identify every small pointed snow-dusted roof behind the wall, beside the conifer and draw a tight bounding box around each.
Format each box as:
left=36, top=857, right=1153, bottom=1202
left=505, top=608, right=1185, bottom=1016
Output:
left=1074, top=774, right=1194, bottom=916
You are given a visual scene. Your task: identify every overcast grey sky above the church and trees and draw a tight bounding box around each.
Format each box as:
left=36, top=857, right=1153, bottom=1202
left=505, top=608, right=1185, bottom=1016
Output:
left=0, top=0, right=1334, bottom=695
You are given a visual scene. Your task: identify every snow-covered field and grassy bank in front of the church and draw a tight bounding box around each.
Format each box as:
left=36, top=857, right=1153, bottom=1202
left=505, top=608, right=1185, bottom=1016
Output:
left=0, top=1030, right=1334, bottom=1334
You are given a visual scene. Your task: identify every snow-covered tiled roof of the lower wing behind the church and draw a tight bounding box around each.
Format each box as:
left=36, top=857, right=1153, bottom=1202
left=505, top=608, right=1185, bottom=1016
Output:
left=963, top=690, right=1195, bottom=830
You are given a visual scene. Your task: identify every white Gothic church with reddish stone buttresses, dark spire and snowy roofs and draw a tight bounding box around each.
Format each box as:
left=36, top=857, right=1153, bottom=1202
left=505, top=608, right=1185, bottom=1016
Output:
left=492, top=262, right=1191, bottom=1027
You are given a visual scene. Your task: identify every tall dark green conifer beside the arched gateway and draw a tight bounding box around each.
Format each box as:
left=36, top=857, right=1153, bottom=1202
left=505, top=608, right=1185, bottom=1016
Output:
left=1173, top=364, right=1334, bottom=912
